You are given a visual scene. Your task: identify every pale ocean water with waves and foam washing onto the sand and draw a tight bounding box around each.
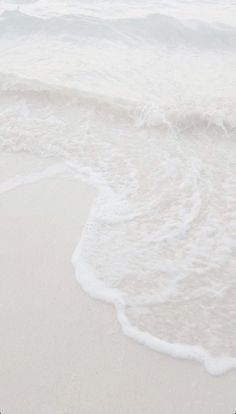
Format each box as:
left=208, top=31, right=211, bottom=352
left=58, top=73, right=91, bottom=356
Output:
left=0, top=0, right=236, bottom=374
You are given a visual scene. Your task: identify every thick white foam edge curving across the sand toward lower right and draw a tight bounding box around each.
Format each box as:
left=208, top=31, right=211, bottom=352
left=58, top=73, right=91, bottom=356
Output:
left=72, top=249, right=236, bottom=375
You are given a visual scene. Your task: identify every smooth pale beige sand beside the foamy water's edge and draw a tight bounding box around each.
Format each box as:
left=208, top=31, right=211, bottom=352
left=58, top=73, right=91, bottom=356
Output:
left=0, top=155, right=236, bottom=414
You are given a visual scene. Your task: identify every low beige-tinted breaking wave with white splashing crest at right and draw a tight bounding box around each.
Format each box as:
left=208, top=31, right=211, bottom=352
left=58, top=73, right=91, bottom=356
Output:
left=0, top=73, right=236, bottom=134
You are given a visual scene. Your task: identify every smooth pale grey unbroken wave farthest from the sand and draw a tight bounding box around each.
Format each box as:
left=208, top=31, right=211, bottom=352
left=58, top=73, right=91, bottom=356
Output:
left=0, top=10, right=236, bottom=49
